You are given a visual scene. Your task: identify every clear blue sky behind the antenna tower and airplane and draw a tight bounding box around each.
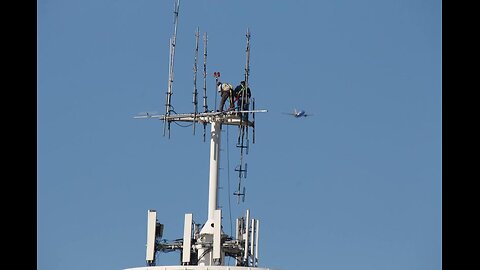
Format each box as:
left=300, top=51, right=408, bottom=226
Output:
left=37, top=0, right=442, bottom=270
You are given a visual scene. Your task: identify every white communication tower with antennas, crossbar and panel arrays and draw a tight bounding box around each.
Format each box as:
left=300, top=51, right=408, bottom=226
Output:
left=125, top=0, right=268, bottom=270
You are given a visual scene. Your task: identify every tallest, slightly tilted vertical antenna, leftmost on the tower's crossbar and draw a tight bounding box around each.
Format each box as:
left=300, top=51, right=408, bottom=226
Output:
left=163, top=0, right=180, bottom=138
